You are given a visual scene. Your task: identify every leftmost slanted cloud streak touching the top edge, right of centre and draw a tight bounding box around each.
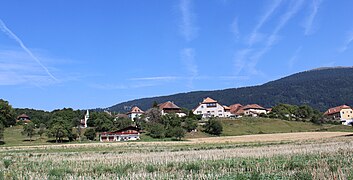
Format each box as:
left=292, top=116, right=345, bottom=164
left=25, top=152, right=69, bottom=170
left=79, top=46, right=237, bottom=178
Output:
left=248, top=0, right=282, bottom=46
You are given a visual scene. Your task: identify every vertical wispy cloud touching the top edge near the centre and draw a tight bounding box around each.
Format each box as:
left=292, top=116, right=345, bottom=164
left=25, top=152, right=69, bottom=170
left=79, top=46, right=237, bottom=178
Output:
left=179, top=0, right=198, bottom=42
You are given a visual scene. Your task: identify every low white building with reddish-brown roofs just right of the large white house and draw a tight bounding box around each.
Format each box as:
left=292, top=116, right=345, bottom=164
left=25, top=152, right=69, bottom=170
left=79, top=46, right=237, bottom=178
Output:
left=230, top=104, right=269, bottom=117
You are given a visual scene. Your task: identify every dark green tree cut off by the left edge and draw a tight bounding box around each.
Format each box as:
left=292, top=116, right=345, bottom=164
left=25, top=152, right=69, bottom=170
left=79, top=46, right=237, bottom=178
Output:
left=0, top=99, right=16, bottom=127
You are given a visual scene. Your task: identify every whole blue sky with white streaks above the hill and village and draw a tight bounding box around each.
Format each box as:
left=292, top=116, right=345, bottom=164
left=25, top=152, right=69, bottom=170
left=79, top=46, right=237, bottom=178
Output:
left=0, top=0, right=353, bottom=110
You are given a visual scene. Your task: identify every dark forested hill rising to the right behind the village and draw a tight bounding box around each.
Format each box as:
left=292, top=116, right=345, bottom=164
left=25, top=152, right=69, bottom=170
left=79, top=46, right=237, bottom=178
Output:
left=108, top=67, right=353, bottom=112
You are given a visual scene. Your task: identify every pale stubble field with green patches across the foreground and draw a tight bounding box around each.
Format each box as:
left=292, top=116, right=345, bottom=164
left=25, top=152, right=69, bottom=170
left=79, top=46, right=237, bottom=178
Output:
left=0, top=132, right=353, bottom=179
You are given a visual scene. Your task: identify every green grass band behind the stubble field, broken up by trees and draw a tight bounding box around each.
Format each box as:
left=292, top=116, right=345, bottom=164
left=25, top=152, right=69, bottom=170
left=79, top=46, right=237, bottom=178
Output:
left=0, top=118, right=353, bottom=147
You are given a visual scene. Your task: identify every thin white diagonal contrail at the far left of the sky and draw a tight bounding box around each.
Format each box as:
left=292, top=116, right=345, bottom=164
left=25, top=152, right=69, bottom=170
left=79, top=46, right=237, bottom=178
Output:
left=0, top=19, right=58, bottom=81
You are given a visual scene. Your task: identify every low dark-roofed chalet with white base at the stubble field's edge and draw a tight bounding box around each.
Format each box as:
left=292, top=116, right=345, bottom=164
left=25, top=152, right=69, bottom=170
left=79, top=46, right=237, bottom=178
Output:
left=99, top=126, right=140, bottom=142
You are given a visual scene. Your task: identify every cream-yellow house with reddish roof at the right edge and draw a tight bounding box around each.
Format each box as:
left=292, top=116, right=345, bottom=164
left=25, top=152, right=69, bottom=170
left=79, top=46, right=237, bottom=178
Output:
left=324, top=105, right=353, bottom=125
